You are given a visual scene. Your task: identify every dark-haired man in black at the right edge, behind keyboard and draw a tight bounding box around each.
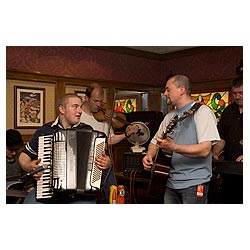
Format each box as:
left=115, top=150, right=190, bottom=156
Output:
left=213, top=76, right=243, bottom=204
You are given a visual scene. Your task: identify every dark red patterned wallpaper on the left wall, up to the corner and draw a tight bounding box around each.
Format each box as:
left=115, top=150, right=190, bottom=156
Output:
left=6, top=46, right=161, bottom=85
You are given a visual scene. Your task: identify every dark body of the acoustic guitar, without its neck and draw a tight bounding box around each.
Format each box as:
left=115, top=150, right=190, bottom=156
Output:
left=148, top=154, right=171, bottom=199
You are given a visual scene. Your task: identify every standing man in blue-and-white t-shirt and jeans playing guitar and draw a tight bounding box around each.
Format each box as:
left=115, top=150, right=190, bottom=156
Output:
left=143, top=75, right=220, bottom=204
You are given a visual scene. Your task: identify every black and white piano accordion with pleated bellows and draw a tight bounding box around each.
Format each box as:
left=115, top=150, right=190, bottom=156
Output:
left=36, top=126, right=106, bottom=200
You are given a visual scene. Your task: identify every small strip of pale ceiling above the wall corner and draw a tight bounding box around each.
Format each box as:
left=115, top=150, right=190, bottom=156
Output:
left=125, top=46, right=197, bottom=54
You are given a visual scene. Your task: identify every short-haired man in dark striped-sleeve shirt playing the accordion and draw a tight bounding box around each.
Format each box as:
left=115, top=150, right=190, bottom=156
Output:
left=19, top=93, right=116, bottom=204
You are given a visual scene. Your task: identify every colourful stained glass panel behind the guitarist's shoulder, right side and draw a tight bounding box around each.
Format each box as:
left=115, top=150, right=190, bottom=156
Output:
left=191, top=91, right=229, bottom=119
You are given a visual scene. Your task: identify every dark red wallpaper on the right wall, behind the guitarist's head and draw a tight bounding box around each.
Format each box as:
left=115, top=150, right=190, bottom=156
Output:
left=162, top=47, right=243, bottom=81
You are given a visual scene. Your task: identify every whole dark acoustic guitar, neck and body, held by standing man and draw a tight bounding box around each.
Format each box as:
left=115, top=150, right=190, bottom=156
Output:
left=148, top=102, right=201, bottom=198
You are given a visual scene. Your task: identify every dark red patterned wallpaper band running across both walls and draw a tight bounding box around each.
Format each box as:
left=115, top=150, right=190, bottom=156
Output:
left=6, top=46, right=243, bottom=86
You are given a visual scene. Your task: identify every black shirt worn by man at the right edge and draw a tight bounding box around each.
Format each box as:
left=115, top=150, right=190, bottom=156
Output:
left=218, top=103, right=243, bottom=161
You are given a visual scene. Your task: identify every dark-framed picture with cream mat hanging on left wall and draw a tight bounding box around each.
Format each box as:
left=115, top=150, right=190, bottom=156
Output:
left=14, top=86, right=45, bottom=128
